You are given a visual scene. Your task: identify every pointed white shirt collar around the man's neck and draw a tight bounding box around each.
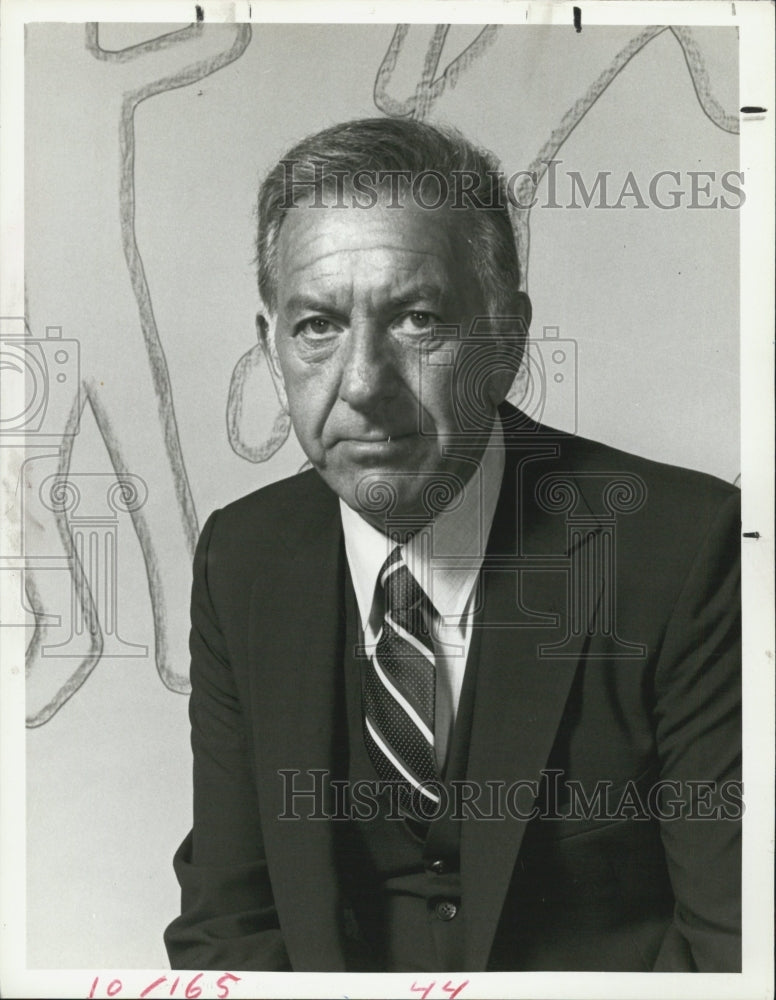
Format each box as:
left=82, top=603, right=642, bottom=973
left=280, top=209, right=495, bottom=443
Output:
left=340, top=417, right=504, bottom=632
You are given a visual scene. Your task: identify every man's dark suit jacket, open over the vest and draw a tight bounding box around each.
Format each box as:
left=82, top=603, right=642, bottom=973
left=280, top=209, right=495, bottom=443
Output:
left=166, top=408, right=741, bottom=971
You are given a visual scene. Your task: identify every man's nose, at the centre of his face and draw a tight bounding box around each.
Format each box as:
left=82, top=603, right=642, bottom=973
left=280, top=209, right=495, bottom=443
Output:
left=339, top=321, right=401, bottom=413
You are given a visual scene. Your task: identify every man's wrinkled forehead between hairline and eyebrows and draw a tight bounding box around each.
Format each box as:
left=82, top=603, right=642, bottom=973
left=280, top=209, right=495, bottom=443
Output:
left=277, top=201, right=471, bottom=299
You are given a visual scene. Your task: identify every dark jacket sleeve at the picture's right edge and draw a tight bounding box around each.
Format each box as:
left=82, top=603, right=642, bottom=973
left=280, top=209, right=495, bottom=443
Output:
left=654, top=491, right=743, bottom=972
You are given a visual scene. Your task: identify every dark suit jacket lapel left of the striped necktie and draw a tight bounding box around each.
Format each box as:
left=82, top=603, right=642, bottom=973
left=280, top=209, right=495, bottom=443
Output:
left=251, top=477, right=346, bottom=971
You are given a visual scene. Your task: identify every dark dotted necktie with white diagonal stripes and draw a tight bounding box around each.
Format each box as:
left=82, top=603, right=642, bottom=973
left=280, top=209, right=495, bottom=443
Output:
left=362, top=546, right=439, bottom=820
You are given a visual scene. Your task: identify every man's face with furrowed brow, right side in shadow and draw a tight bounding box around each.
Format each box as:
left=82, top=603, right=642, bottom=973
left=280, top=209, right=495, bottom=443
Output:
left=266, top=193, right=516, bottom=522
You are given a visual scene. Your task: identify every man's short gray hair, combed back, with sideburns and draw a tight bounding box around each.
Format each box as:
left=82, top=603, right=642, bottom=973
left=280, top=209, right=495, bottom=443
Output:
left=256, top=118, right=520, bottom=316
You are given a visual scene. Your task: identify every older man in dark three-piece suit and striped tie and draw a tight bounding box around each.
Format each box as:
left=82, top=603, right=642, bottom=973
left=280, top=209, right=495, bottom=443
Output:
left=166, top=119, right=742, bottom=971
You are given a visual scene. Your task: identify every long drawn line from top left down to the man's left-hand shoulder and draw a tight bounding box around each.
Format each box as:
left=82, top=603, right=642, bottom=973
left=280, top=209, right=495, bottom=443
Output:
left=119, top=24, right=251, bottom=554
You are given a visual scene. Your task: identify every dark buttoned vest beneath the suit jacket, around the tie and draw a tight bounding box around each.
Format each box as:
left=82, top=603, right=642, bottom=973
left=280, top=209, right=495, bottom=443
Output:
left=340, top=574, right=477, bottom=972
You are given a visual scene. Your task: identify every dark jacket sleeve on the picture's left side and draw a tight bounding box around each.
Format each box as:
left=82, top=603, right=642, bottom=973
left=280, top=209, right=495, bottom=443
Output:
left=164, top=512, right=291, bottom=971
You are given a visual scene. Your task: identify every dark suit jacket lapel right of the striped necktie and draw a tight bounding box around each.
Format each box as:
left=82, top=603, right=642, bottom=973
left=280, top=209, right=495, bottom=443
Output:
left=461, top=435, right=600, bottom=969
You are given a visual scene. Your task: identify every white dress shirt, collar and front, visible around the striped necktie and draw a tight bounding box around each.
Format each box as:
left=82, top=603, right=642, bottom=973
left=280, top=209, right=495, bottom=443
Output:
left=340, top=417, right=504, bottom=774
